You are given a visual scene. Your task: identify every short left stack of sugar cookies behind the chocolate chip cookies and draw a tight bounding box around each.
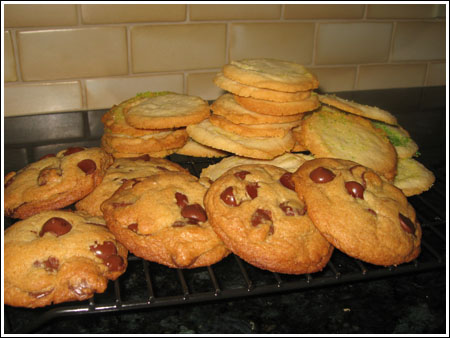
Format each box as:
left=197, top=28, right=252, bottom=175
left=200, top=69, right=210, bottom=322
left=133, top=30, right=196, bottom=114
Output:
left=102, top=92, right=222, bottom=158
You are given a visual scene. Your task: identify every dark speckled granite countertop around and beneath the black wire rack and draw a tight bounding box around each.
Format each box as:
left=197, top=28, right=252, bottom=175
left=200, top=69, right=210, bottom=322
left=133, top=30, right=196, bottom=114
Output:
left=3, top=87, right=448, bottom=334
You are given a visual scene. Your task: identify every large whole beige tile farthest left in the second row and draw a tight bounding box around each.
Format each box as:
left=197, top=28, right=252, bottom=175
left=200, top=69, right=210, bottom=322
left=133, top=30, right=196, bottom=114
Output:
left=17, top=27, right=128, bottom=81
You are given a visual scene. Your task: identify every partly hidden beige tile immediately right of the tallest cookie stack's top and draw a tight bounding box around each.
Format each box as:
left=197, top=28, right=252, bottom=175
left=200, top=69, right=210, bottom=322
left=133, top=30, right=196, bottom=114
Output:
left=309, top=67, right=356, bottom=93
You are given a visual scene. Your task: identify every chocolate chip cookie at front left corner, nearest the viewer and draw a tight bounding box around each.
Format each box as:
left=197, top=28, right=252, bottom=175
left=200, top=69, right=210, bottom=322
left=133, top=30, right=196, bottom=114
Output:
left=4, top=210, right=127, bottom=308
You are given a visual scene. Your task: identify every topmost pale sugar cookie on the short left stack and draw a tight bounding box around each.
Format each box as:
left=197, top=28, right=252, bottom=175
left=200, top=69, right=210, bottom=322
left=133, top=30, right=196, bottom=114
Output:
left=123, top=93, right=210, bottom=129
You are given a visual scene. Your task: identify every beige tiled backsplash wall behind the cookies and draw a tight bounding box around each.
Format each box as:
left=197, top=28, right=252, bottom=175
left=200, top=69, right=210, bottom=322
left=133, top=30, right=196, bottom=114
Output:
left=3, top=4, right=446, bottom=116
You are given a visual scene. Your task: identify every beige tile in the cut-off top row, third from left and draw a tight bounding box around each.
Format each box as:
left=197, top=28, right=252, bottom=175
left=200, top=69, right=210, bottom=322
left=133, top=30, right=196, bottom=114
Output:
left=189, top=4, right=281, bottom=20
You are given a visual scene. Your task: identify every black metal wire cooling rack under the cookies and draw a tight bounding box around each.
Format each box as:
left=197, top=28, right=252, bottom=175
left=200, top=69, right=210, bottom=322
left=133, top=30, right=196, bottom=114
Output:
left=4, top=157, right=447, bottom=333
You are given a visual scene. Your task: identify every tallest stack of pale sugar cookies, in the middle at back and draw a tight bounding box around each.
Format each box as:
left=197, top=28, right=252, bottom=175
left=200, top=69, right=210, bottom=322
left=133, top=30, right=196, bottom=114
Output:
left=187, top=59, right=320, bottom=159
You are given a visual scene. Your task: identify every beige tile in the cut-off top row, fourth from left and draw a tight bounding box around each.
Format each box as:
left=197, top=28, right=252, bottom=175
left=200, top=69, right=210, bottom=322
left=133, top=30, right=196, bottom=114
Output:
left=284, top=4, right=364, bottom=20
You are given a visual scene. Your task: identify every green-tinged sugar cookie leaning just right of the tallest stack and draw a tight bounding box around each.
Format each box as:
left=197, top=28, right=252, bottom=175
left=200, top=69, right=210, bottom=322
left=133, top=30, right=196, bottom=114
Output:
left=299, top=106, right=397, bottom=180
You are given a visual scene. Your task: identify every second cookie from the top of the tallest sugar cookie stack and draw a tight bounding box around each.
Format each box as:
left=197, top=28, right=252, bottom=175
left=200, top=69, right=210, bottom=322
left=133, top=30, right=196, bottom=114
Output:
left=213, top=72, right=311, bottom=102
